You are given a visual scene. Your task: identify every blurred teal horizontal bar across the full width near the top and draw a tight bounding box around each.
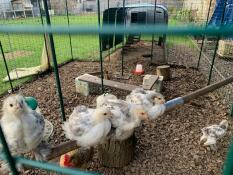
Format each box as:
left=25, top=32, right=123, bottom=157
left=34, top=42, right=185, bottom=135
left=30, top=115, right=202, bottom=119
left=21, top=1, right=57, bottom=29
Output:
left=0, top=25, right=233, bottom=37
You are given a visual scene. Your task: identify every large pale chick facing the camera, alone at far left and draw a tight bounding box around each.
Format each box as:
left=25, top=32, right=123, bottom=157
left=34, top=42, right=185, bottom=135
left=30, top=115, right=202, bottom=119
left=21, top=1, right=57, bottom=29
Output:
left=0, top=95, right=50, bottom=172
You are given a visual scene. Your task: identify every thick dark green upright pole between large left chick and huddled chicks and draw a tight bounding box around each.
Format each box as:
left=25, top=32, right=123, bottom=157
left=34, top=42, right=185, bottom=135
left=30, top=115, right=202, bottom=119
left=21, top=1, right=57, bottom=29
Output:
left=43, top=0, right=66, bottom=121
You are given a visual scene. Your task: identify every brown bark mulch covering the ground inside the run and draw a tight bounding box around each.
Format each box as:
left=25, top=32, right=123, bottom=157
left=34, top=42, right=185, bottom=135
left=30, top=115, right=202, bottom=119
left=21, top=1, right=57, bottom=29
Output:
left=1, top=43, right=232, bottom=175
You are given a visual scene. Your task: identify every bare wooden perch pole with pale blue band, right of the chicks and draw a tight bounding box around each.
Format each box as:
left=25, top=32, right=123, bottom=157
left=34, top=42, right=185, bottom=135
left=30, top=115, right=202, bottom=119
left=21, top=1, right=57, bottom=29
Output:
left=165, top=76, right=233, bottom=111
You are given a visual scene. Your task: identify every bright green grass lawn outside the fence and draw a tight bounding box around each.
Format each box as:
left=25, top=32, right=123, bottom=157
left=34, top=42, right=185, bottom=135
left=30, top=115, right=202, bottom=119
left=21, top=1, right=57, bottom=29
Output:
left=0, top=14, right=191, bottom=94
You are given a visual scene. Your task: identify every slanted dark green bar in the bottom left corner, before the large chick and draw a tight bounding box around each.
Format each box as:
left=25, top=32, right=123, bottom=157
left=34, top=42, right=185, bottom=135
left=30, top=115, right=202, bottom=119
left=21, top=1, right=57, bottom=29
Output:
left=0, top=126, right=19, bottom=175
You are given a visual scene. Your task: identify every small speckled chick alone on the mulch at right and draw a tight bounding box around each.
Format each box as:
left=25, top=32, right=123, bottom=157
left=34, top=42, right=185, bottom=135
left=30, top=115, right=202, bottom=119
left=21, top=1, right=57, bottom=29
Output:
left=200, top=120, right=228, bottom=150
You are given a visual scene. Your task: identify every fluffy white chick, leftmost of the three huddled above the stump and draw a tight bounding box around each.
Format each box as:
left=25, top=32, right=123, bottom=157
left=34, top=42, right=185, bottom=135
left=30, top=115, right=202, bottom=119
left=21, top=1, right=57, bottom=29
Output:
left=62, top=106, right=112, bottom=148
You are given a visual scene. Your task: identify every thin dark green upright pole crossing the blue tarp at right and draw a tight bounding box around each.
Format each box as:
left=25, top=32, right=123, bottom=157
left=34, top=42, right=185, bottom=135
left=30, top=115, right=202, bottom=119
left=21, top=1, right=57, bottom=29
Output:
left=207, top=0, right=227, bottom=85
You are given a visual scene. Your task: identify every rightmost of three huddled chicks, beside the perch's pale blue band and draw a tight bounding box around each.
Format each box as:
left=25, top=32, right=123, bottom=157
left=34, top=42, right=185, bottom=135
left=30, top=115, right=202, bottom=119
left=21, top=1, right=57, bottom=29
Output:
left=126, top=88, right=165, bottom=119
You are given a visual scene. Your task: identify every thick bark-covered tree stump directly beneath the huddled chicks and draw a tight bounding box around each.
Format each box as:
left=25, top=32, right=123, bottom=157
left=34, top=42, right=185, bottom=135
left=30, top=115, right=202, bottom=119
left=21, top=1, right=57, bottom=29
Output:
left=98, top=135, right=135, bottom=168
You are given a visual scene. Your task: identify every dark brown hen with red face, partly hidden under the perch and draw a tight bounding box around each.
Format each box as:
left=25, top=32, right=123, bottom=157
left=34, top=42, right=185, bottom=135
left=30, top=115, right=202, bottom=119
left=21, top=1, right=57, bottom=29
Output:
left=60, top=147, right=94, bottom=169
